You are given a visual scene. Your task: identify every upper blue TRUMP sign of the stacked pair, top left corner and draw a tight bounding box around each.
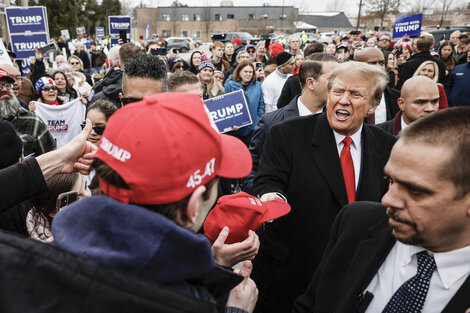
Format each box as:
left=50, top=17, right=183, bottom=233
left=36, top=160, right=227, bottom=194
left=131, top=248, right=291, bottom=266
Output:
left=5, top=7, right=48, bottom=34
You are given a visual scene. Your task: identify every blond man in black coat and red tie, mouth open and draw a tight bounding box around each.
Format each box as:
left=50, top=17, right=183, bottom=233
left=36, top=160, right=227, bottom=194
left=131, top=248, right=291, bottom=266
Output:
left=253, top=61, right=395, bottom=313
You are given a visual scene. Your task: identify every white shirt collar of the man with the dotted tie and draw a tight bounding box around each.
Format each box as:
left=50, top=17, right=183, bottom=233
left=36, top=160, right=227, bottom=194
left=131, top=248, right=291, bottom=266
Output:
left=397, top=241, right=470, bottom=289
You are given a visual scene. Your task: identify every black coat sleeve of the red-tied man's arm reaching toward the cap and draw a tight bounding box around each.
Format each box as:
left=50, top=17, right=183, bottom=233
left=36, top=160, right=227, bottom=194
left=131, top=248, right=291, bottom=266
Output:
left=253, top=124, right=292, bottom=195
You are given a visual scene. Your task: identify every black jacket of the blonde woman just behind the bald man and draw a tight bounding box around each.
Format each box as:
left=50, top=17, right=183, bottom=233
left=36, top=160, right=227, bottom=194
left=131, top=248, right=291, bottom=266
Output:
left=397, top=51, right=446, bottom=90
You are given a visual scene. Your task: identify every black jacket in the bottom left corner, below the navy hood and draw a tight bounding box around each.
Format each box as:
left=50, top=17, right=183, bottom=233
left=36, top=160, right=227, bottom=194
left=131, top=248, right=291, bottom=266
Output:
left=0, top=231, right=242, bottom=313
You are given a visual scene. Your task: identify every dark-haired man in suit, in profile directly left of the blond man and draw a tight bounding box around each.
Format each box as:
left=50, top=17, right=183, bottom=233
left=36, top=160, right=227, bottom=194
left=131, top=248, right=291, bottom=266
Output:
left=242, top=53, right=338, bottom=193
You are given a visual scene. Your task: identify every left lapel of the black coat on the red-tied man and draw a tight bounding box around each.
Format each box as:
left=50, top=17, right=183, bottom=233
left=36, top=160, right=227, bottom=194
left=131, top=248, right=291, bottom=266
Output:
left=312, top=113, right=348, bottom=207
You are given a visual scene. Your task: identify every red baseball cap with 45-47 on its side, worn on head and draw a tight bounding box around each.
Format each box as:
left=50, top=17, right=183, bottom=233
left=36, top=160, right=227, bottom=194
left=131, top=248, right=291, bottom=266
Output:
left=95, top=93, right=252, bottom=204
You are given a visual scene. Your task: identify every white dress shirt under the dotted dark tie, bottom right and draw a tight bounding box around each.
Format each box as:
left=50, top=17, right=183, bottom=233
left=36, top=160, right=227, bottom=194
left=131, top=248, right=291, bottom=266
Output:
left=364, top=241, right=470, bottom=313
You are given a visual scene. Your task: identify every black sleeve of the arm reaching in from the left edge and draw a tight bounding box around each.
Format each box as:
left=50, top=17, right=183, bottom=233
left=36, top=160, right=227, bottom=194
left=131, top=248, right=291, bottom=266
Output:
left=0, top=158, right=47, bottom=211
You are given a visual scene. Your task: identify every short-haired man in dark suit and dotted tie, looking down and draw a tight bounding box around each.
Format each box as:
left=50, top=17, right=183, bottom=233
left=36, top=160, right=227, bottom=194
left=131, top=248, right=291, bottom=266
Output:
left=293, top=107, right=470, bottom=313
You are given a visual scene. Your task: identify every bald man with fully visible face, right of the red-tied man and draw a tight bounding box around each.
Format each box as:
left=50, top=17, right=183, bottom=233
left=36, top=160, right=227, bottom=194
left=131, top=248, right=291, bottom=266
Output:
left=377, top=76, right=439, bottom=136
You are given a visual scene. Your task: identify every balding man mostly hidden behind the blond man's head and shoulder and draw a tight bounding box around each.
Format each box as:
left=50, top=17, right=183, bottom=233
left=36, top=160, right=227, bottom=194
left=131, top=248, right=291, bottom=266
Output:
left=354, top=47, right=400, bottom=125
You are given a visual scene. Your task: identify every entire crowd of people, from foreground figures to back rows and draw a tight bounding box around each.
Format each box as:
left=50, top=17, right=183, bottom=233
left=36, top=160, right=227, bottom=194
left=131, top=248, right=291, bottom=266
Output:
left=0, top=25, right=470, bottom=313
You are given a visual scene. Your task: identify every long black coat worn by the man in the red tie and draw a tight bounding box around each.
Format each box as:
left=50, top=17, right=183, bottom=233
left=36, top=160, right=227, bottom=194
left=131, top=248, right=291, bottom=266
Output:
left=252, top=113, right=396, bottom=313
